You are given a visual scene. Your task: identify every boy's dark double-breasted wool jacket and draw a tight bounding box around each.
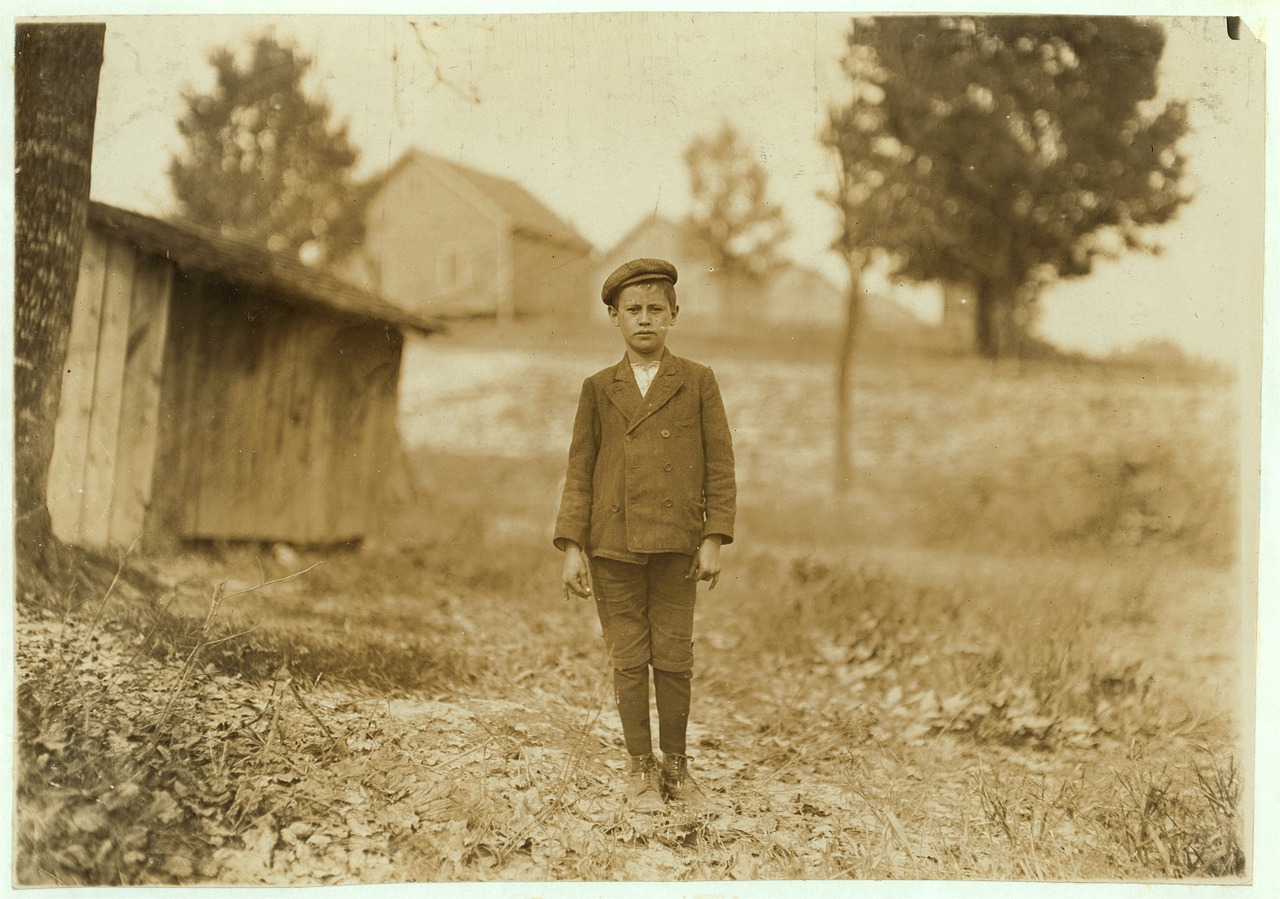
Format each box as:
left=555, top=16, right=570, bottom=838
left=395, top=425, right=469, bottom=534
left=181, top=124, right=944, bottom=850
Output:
left=556, top=351, right=737, bottom=561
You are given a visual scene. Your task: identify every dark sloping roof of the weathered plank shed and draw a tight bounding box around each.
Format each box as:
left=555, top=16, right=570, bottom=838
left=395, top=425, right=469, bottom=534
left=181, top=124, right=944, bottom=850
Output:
left=88, top=201, right=444, bottom=334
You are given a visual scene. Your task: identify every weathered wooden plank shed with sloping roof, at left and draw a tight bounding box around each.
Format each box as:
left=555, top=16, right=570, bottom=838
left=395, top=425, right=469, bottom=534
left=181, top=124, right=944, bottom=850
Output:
left=49, top=202, right=439, bottom=547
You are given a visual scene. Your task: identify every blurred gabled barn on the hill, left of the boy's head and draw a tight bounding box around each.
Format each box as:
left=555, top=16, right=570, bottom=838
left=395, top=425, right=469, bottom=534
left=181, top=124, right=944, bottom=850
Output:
left=335, top=150, right=598, bottom=320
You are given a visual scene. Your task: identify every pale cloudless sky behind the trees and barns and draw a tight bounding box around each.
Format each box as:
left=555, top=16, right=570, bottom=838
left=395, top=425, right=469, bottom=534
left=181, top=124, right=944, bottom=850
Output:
left=85, top=13, right=1263, bottom=360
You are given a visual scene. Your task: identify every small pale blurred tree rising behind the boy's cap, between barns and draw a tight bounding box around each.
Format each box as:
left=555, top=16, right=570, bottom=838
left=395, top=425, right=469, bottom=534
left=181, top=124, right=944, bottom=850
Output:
left=685, top=123, right=790, bottom=280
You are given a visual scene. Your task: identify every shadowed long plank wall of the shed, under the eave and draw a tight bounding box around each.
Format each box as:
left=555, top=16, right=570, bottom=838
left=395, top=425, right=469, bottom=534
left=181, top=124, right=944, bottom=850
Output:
left=155, top=279, right=402, bottom=544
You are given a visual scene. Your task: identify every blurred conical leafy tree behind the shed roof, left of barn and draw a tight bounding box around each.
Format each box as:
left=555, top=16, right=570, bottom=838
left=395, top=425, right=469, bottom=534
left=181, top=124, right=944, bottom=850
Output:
left=169, top=36, right=364, bottom=263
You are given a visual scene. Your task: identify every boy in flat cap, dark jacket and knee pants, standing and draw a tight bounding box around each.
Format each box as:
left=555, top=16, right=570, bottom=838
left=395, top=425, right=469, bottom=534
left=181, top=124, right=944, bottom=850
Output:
left=556, top=259, right=736, bottom=812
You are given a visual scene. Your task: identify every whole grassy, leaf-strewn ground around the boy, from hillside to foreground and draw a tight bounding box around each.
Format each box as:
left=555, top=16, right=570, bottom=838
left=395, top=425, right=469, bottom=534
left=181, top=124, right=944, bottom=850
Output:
left=18, top=325, right=1252, bottom=884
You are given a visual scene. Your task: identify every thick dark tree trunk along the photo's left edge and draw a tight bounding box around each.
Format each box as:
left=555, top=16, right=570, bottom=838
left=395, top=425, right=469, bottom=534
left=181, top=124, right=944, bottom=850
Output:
left=13, top=24, right=106, bottom=595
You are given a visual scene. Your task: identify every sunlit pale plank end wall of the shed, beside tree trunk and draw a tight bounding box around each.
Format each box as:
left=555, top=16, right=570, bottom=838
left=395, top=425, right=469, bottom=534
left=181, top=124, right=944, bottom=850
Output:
left=47, top=228, right=173, bottom=546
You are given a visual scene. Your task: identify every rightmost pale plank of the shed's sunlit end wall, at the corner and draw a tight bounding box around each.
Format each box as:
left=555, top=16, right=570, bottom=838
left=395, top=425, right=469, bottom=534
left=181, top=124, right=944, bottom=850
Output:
left=110, top=257, right=173, bottom=546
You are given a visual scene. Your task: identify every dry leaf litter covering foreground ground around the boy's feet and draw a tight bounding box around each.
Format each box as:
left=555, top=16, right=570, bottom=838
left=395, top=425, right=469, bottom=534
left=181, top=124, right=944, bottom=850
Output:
left=18, top=537, right=1234, bottom=885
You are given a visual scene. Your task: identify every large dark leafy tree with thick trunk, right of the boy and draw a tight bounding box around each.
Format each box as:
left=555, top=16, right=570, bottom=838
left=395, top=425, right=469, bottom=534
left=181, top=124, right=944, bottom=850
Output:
left=826, top=15, right=1189, bottom=357
